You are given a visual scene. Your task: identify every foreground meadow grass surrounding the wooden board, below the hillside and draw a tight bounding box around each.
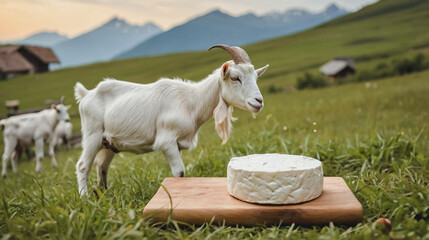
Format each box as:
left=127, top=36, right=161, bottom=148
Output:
left=0, top=71, right=429, bottom=239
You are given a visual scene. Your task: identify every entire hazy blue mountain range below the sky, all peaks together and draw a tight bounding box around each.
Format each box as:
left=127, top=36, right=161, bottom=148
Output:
left=0, top=4, right=348, bottom=69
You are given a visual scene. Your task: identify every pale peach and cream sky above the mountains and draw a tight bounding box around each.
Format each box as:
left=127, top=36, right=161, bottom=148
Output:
left=0, top=0, right=377, bottom=40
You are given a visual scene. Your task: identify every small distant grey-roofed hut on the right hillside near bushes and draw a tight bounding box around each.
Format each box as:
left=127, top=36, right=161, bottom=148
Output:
left=319, top=57, right=356, bottom=79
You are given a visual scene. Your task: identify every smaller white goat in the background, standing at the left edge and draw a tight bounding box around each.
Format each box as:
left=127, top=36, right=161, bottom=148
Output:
left=0, top=97, right=70, bottom=178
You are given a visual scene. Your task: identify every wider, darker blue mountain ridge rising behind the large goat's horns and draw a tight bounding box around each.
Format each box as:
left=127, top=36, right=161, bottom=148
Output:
left=115, top=4, right=348, bottom=59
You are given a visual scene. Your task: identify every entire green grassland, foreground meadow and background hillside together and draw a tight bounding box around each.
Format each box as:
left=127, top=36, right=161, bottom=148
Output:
left=0, top=0, right=429, bottom=239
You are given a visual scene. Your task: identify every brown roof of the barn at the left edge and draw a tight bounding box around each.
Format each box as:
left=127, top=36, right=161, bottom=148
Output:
left=0, top=45, right=59, bottom=72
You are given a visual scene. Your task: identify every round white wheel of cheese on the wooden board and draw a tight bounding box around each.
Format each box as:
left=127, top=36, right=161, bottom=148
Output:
left=227, top=154, right=323, bottom=204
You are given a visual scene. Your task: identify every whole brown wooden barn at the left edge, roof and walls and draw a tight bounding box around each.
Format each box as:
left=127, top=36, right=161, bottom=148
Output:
left=0, top=45, right=60, bottom=79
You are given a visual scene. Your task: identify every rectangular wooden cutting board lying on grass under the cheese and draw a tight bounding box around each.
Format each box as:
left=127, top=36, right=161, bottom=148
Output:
left=143, top=177, right=363, bottom=225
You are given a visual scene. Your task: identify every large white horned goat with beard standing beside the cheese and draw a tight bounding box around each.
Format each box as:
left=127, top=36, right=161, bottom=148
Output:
left=75, top=45, right=268, bottom=196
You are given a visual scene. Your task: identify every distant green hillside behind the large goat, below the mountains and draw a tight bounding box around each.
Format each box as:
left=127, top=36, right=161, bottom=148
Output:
left=0, top=0, right=429, bottom=116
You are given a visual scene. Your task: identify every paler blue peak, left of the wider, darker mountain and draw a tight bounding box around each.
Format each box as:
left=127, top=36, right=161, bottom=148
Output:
left=52, top=17, right=163, bottom=67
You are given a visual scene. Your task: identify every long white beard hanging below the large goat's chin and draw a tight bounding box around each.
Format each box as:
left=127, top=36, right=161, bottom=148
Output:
left=213, top=97, right=231, bottom=144
